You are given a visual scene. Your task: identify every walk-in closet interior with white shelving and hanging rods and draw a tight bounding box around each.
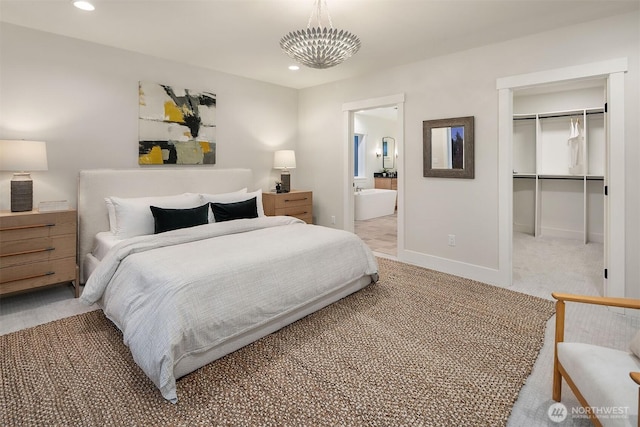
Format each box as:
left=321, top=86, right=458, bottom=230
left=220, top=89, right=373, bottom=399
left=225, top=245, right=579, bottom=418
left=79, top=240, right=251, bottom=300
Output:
left=513, top=80, right=607, bottom=294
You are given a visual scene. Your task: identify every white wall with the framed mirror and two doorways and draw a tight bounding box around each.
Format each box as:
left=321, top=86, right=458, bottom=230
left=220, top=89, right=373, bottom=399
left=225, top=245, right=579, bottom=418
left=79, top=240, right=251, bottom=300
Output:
left=297, top=13, right=640, bottom=297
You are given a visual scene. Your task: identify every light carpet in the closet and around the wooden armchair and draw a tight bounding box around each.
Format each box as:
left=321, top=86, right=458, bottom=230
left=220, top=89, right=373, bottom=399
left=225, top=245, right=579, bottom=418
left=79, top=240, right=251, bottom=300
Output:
left=508, top=233, right=640, bottom=427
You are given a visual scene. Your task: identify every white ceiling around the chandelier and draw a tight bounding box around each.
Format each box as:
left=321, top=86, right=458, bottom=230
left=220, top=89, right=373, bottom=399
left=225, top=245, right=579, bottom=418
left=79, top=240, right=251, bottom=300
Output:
left=0, top=0, right=640, bottom=89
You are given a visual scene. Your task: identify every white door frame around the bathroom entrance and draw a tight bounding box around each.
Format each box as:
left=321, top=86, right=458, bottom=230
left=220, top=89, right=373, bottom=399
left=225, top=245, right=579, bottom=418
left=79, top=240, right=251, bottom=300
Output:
left=342, top=93, right=405, bottom=254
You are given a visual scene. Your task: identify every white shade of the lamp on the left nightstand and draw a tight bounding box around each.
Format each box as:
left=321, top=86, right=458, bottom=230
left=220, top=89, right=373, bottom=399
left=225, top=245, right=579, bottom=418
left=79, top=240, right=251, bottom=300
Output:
left=0, top=140, right=49, bottom=172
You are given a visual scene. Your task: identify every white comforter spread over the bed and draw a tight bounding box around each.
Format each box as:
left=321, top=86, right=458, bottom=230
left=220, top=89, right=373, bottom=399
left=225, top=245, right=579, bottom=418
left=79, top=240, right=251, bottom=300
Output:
left=81, top=217, right=377, bottom=402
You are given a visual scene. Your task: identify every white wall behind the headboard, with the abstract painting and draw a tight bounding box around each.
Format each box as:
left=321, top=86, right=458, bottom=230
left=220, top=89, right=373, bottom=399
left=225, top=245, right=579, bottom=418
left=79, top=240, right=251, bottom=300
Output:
left=0, top=23, right=298, bottom=209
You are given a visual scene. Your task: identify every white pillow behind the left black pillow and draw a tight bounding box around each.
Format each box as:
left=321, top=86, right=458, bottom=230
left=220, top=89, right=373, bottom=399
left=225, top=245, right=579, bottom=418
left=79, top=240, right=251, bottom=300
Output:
left=105, top=193, right=200, bottom=239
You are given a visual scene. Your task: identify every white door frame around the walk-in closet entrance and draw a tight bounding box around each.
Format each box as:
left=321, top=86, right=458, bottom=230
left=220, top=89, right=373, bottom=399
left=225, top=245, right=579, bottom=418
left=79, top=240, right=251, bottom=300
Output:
left=496, top=58, right=628, bottom=297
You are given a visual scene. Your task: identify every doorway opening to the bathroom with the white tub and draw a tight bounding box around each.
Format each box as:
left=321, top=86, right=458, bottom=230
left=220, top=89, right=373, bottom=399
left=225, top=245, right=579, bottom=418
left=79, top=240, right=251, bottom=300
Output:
left=343, top=94, right=404, bottom=258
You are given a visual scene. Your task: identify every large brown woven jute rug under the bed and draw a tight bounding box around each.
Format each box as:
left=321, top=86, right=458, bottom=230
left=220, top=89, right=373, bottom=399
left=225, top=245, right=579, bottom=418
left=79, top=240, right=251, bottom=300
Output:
left=0, top=259, right=554, bottom=426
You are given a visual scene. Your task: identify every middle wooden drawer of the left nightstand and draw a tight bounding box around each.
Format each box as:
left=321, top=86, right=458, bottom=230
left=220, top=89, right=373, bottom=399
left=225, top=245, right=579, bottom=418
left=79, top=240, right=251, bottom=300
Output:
left=0, top=234, right=76, bottom=268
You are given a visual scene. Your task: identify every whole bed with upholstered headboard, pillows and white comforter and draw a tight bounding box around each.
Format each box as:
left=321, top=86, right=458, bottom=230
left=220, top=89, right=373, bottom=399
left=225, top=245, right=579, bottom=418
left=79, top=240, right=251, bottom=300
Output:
left=78, top=168, right=377, bottom=403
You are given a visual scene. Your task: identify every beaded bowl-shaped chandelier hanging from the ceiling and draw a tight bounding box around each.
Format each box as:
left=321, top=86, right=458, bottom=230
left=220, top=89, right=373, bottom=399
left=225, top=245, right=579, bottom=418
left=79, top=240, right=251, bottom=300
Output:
left=280, top=0, right=360, bottom=69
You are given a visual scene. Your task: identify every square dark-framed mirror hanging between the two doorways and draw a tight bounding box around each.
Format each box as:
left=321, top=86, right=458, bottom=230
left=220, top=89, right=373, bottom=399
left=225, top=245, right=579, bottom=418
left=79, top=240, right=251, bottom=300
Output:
left=422, top=116, right=474, bottom=179
